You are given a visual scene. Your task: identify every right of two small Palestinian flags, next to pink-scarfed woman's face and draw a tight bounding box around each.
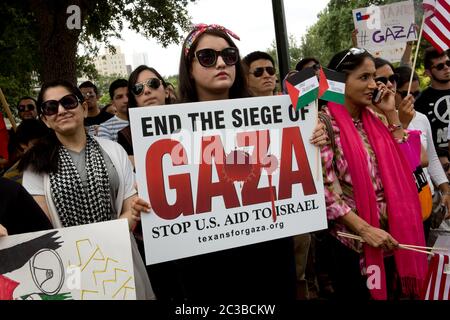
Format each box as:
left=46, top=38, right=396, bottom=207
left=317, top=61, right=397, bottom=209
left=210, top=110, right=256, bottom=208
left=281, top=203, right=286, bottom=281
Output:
left=319, top=68, right=345, bottom=104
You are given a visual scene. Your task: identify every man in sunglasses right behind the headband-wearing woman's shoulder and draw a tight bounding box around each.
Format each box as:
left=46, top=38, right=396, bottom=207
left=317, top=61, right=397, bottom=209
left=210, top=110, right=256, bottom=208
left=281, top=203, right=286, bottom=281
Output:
left=242, top=51, right=277, bottom=97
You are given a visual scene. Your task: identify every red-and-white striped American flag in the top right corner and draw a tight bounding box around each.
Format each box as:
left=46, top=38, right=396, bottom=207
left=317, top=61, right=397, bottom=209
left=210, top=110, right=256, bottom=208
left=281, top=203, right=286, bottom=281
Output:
left=423, top=0, right=450, bottom=52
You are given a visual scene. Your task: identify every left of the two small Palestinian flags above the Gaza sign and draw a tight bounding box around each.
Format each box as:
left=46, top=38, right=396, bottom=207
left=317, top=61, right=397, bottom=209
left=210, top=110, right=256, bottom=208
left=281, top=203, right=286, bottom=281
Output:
left=286, top=68, right=319, bottom=110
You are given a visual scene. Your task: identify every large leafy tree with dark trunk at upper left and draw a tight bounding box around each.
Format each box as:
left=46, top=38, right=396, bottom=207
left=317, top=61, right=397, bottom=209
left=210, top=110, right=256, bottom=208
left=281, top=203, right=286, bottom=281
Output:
left=0, top=0, right=196, bottom=117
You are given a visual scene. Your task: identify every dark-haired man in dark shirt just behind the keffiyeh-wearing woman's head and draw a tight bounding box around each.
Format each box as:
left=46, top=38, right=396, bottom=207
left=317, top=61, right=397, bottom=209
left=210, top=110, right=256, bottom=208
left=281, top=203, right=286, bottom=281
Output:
left=79, top=81, right=113, bottom=136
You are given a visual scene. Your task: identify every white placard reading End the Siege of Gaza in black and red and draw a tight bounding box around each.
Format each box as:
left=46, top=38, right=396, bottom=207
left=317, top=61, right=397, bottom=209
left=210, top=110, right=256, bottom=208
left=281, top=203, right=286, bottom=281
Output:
left=130, top=95, right=327, bottom=264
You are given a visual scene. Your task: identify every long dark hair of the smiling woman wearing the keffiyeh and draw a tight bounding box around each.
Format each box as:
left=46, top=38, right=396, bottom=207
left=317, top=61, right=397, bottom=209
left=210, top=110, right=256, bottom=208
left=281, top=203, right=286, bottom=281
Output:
left=18, top=80, right=84, bottom=174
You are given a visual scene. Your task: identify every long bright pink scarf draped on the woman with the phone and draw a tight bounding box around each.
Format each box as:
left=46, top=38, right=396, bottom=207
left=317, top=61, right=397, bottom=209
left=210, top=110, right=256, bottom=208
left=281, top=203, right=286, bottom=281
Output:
left=328, top=103, right=427, bottom=300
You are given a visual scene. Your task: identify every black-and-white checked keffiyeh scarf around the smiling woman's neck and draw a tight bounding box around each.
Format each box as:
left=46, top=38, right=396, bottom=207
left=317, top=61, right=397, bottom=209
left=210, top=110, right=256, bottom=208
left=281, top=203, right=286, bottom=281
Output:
left=50, top=135, right=111, bottom=227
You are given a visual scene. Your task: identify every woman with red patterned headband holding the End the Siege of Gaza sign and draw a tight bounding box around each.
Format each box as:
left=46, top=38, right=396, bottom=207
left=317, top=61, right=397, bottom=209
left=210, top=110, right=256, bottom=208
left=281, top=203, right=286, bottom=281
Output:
left=134, top=24, right=326, bottom=301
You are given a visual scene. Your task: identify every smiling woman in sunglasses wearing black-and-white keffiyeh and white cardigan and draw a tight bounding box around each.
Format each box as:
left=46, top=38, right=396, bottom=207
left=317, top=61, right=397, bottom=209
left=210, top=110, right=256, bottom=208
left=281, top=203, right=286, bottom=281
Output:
left=22, top=81, right=154, bottom=299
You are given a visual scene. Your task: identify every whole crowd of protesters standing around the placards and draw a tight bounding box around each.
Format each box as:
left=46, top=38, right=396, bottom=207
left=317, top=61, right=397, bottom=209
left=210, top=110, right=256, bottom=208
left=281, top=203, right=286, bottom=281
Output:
left=0, top=24, right=450, bottom=301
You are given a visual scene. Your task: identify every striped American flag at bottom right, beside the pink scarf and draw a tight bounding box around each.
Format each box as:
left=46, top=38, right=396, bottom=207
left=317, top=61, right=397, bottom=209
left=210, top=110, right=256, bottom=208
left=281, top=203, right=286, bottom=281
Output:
left=423, top=254, right=450, bottom=300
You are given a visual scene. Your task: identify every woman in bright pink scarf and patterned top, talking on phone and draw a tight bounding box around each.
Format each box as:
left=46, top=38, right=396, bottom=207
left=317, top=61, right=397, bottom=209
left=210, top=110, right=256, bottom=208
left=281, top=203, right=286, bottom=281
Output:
left=322, top=48, right=427, bottom=300
